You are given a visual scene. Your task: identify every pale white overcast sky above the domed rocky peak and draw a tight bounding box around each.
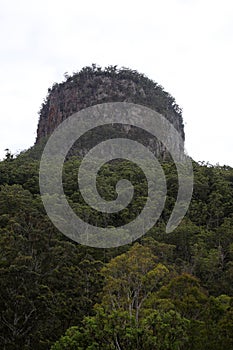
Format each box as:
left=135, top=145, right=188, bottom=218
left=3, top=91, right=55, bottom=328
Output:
left=0, top=0, right=233, bottom=166
